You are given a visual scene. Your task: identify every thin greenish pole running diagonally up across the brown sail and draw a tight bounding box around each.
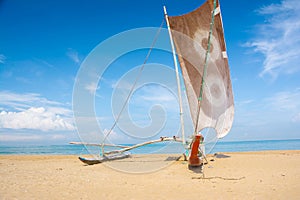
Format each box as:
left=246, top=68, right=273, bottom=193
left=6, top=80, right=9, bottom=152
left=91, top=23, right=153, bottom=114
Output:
left=194, top=0, right=217, bottom=134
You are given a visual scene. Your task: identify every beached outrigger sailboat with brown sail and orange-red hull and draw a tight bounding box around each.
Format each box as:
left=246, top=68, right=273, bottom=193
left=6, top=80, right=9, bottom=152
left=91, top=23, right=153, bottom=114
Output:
left=70, top=0, right=234, bottom=167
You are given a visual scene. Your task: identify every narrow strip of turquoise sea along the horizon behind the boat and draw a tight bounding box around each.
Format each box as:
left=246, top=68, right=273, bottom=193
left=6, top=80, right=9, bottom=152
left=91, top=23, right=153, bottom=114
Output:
left=0, top=139, right=300, bottom=155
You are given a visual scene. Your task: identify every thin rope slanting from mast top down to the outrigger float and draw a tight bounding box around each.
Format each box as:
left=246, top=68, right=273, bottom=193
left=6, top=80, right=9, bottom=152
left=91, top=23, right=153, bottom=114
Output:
left=101, top=20, right=164, bottom=155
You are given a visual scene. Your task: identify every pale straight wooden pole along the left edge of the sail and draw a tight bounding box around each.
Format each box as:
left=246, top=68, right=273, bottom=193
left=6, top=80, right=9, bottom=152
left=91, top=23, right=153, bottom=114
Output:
left=164, top=6, right=185, bottom=145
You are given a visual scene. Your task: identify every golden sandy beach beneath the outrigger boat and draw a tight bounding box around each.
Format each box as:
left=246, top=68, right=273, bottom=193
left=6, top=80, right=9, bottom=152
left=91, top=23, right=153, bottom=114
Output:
left=0, top=151, right=300, bottom=200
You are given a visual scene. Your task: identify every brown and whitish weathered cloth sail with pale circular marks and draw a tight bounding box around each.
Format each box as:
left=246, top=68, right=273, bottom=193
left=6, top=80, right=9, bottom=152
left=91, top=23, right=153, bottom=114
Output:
left=168, top=0, right=234, bottom=138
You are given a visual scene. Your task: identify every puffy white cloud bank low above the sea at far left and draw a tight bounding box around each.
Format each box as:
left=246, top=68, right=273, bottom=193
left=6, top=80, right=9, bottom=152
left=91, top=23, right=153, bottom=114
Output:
left=0, top=91, right=75, bottom=131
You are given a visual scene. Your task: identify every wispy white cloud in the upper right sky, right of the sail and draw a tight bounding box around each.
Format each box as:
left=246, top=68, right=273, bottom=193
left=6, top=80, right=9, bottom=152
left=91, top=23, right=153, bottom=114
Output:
left=247, top=0, right=300, bottom=79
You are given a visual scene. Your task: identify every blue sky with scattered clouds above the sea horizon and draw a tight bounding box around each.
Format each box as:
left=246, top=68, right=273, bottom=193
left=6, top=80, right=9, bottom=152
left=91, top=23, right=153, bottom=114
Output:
left=0, top=0, right=300, bottom=145
